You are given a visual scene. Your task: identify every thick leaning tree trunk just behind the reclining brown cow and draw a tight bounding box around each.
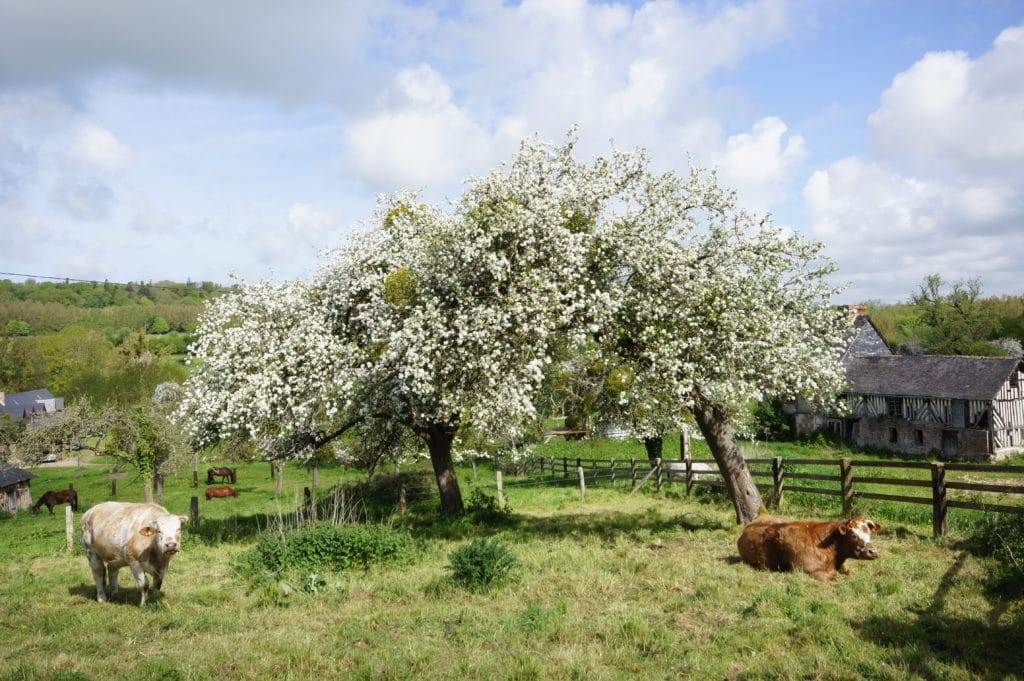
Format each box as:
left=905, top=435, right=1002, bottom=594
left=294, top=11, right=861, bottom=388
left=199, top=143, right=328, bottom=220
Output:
left=693, top=394, right=761, bottom=525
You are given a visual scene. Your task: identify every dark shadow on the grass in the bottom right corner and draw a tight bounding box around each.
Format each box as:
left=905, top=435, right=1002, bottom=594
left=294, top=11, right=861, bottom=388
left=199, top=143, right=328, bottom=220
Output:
left=854, top=552, right=1024, bottom=680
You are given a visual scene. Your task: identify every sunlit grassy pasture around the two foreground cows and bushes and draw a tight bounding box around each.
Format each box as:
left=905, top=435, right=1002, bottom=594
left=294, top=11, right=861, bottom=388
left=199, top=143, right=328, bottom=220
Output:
left=0, top=442, right=1024, bottom=681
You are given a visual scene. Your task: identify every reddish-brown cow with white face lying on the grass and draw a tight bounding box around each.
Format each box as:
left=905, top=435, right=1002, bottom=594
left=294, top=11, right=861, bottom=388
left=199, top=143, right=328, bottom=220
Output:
left=737, top=515, right=882, bottom=580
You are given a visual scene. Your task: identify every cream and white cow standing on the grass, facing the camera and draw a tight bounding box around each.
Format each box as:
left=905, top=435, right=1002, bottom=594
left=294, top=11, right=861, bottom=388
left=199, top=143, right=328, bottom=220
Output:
left=82, top=502, right=188, bottom=605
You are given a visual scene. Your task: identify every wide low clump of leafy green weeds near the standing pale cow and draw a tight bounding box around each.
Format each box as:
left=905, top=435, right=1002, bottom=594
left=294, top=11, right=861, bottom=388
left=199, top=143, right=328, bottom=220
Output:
left=241, top=522, right=416, bottom=574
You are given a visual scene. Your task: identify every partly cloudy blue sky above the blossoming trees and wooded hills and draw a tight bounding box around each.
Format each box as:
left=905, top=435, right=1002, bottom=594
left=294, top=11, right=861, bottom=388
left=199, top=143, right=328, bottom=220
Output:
left=0, top=0, right=1024, bottom=302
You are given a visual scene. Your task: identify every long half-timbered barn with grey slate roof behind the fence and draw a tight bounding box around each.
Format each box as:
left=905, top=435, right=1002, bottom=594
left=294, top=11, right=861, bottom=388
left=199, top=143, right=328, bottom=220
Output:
left=827, top=354, right=1024, bottom=459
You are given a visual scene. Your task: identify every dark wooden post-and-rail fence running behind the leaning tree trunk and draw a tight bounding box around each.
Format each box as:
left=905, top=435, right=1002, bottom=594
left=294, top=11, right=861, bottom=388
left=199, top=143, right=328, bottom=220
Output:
left=516, top=457, right=1024, bottom=537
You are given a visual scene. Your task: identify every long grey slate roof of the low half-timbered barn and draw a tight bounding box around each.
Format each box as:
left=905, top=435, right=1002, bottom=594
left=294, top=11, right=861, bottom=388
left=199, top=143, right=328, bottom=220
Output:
left=846, top=354, right=1024, bottom=399
